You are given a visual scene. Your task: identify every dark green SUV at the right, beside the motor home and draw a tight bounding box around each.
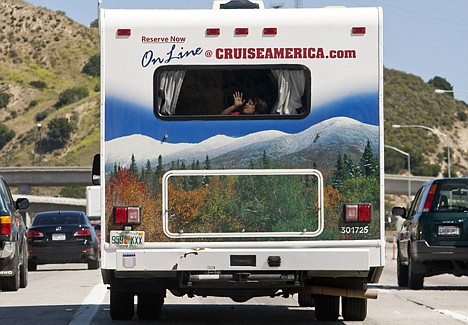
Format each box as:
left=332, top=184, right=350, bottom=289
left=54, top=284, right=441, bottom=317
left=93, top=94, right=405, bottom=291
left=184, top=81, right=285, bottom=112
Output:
left=392, top=178, right=468, bottom=289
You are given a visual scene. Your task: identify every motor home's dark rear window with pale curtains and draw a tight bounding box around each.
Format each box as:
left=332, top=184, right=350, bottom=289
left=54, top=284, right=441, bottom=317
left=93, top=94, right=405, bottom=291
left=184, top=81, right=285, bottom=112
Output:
left=154, top=65, right=311, bottom=119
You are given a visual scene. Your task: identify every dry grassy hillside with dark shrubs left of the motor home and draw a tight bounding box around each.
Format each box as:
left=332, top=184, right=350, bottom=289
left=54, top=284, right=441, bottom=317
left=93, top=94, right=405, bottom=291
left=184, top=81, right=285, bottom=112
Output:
left=0, top=0, right=99, bottom=166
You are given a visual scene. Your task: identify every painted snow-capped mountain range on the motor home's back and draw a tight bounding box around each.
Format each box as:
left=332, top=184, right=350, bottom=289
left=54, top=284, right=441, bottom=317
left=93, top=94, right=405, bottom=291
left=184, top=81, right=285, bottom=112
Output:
left=106, top=117, right=379, bottom=169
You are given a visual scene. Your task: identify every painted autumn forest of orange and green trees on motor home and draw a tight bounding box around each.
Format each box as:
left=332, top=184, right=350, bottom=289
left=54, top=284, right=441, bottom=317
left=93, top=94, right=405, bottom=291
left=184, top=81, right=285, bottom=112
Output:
left=106, top=141, right=380, bottom=242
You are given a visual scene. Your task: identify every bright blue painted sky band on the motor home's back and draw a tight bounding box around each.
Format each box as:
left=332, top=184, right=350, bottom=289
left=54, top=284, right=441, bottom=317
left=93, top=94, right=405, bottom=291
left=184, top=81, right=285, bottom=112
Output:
left=105, top=94, right=379, bottom=143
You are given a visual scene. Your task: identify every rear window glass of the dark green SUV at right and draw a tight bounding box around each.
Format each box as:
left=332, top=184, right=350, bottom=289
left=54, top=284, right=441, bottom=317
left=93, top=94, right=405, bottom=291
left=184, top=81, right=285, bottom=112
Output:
left=434, top=183, right=468, bottom=211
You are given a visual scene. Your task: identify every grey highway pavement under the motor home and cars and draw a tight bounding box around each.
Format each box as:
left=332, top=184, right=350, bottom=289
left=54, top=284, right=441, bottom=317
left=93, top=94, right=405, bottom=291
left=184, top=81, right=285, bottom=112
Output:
left=0, top=243, right=468, bottom=325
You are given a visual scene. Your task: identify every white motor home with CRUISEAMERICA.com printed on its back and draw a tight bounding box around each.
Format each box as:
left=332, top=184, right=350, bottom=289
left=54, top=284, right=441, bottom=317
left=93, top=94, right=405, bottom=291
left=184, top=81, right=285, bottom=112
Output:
left=93, top=0, right=385, bottom=320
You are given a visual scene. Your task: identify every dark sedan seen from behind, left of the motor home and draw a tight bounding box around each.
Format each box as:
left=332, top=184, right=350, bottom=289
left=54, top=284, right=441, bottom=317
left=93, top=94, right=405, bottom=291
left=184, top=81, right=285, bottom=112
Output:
left=28, top=211, right=100, bottom=271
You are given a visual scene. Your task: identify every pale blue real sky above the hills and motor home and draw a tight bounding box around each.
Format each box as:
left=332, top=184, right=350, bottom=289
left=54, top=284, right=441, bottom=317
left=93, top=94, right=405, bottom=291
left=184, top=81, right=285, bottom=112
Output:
left=26, top=0, right=468, bottom=103
